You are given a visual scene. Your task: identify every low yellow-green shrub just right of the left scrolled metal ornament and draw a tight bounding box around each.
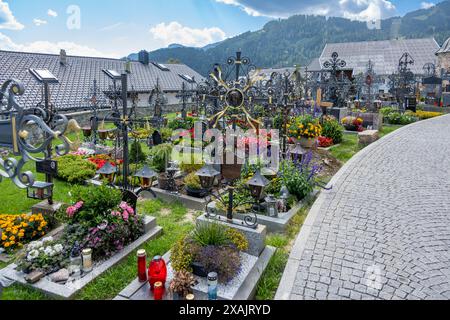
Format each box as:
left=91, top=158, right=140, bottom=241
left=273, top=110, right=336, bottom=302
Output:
left=57, top=154, right=97, bottom=183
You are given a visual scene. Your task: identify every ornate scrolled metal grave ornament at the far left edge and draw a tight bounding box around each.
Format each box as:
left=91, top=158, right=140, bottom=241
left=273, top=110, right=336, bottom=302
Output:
left=0, top=80, right=71, bottom=189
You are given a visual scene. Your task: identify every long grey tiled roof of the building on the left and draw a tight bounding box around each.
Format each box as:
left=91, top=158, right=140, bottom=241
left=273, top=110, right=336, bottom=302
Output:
left=0, top=50, right=203, bottom=109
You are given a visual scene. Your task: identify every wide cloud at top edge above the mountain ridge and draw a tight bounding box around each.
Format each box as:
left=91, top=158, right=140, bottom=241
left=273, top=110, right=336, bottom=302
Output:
left=216, top=0, right=396, bottom=21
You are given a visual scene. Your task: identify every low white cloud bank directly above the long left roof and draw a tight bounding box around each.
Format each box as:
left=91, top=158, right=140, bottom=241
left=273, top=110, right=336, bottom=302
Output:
left=0, top=32, right=117, bottom=58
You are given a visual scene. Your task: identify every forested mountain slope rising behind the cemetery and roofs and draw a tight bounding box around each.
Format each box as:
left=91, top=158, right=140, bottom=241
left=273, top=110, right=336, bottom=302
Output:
left=130, top=0, right=450, bottom=75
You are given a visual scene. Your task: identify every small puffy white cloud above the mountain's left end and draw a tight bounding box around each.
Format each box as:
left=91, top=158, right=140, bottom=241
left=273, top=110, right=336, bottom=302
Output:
left=150, top=21, right=226, bottom=47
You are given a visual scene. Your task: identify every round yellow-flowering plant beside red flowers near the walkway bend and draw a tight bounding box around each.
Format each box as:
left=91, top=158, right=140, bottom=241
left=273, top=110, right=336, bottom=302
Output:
left=287, top=115, right=322, bottom=148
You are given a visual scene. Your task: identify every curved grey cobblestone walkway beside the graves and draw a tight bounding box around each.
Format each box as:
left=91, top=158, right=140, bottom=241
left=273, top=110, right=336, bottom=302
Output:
left=276, top=116, right=450, bottom=300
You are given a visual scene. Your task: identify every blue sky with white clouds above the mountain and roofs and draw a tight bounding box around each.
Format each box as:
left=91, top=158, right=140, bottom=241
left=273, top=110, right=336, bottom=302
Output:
left=0, top=0, right=437, bottom=57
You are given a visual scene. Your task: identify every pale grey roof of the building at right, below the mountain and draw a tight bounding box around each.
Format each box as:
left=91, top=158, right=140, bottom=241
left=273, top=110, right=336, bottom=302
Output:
left=319, top=38, right=439, bottom=75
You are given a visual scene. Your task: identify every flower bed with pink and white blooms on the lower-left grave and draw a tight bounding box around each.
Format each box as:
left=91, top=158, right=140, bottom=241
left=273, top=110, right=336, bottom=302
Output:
left=14, top=187, right=143, bottom=274
